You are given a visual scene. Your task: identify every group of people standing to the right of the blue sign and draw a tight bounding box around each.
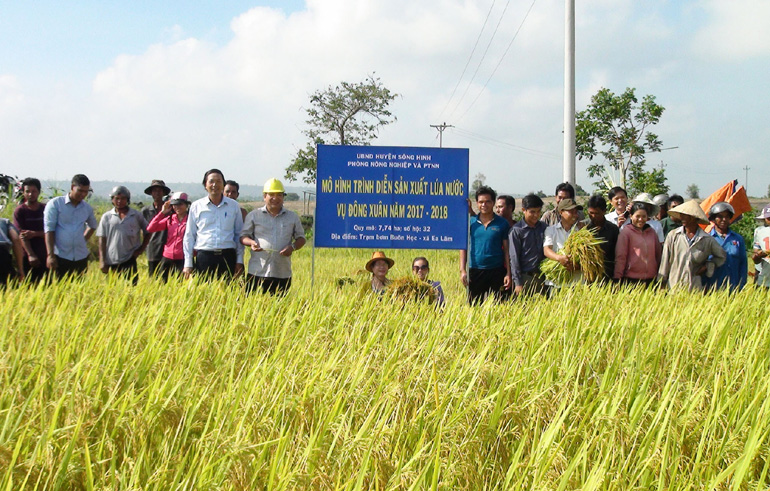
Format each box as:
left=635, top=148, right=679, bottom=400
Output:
left=460, top=183, right=770, bottom=304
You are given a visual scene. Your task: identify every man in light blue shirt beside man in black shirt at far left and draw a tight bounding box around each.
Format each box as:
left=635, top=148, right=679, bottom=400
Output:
left=43, top=174, right=96, bottom=278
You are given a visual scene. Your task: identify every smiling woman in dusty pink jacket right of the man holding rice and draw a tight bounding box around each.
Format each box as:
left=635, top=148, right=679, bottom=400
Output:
left=614, top=202, right=663, bottom=285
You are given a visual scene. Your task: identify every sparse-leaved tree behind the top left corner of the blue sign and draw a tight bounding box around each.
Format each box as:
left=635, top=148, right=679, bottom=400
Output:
left=285, top=75, right=398, bottom=184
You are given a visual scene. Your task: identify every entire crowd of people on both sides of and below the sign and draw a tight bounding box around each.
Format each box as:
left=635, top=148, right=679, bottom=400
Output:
left=0, top=173, right=770, bottom=304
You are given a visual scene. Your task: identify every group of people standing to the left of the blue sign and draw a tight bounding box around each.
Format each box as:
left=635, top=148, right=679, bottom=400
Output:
left=0, top=169, right=305, bottom=293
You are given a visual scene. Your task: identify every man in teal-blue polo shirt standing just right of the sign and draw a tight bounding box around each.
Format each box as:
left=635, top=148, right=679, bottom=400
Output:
left=460, top=186, right=511, bottom=305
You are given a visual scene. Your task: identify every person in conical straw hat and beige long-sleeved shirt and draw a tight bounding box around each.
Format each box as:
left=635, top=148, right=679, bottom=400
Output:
left=658, top=199, right=727, bottom=290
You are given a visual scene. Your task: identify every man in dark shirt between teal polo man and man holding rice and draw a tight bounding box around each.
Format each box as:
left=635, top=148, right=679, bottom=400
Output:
left=508, top=194, right=548, bottom=295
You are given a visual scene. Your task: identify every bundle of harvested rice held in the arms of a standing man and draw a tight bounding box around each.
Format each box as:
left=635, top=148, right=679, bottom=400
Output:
left=540, top=228, right=604, bottom=285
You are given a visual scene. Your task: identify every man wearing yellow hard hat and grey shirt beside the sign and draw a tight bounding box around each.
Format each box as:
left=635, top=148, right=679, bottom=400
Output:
left=241, top=179, right=305, bottom=293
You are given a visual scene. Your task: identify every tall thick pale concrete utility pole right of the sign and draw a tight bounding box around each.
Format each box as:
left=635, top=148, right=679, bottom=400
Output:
left=563, top=0, right=575, bottom=184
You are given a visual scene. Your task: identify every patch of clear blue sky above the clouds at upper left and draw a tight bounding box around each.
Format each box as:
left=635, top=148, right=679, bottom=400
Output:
left=0, top=0, right=304, bottom=82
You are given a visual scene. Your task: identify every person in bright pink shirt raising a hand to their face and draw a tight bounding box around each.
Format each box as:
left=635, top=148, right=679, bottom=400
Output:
left=147, top=191, right=190, bottom=281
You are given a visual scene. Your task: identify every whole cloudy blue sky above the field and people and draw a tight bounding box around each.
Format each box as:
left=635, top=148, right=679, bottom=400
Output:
left=0, top=0, right=770, bottom=199
